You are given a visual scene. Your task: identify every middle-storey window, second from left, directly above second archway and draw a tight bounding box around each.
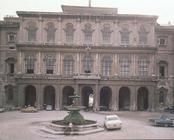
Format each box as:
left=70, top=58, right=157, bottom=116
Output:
left=44, top=55, right=56, bottom=74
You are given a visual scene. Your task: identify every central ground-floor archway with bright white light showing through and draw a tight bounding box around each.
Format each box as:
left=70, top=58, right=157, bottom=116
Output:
left=82, top=86, right=94, bottom=108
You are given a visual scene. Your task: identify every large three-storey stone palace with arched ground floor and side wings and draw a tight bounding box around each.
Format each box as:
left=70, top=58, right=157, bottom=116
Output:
left=0, top=5, right=174, bottom=111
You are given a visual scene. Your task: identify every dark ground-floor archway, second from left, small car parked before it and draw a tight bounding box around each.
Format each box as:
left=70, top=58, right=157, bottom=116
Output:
left=44, top=86, right=55, bottom=109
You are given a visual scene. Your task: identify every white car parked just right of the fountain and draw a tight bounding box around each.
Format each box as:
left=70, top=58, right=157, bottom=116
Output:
left=104, top=115, right=122, bottom=129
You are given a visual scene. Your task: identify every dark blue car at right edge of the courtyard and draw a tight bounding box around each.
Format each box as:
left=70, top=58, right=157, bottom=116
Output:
left=149, top=115, right=174, bottom=127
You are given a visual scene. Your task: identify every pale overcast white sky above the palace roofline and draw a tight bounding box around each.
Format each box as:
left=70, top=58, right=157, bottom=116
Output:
left=0, top=0, right=174, bottom=24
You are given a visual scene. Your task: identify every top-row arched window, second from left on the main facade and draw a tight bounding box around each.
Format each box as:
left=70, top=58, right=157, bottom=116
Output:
left=46, top=22, right=56, bottom=42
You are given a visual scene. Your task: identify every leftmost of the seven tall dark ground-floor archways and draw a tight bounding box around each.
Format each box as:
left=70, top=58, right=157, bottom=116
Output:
left=25, top=85, right=36, bottom=106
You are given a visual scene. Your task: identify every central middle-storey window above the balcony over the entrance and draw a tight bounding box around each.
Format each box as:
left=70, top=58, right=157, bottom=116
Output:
left=83, top=56, right=93, bottom=73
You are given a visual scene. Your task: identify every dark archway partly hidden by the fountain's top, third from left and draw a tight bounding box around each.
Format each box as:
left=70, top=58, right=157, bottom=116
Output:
left=62, top=86, right=74, bottom=106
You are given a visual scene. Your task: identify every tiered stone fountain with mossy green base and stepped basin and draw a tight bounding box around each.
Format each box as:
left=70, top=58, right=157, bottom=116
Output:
left=36, top=94, right=104, bottom=135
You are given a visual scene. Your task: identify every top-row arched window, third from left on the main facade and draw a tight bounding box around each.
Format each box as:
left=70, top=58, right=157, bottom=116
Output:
left=64, top=23, right=75, bottom=43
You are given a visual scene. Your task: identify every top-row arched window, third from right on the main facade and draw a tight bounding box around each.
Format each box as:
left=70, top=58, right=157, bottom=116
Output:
left=101, top=24, right=112, bottom=43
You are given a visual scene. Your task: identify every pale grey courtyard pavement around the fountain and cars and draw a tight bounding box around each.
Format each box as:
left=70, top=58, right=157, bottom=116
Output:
left=0, top=111, right=174, bottom=140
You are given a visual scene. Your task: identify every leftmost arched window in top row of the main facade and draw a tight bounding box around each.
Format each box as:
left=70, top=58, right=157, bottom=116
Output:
left=26, top=22, right=37, bottom=41
